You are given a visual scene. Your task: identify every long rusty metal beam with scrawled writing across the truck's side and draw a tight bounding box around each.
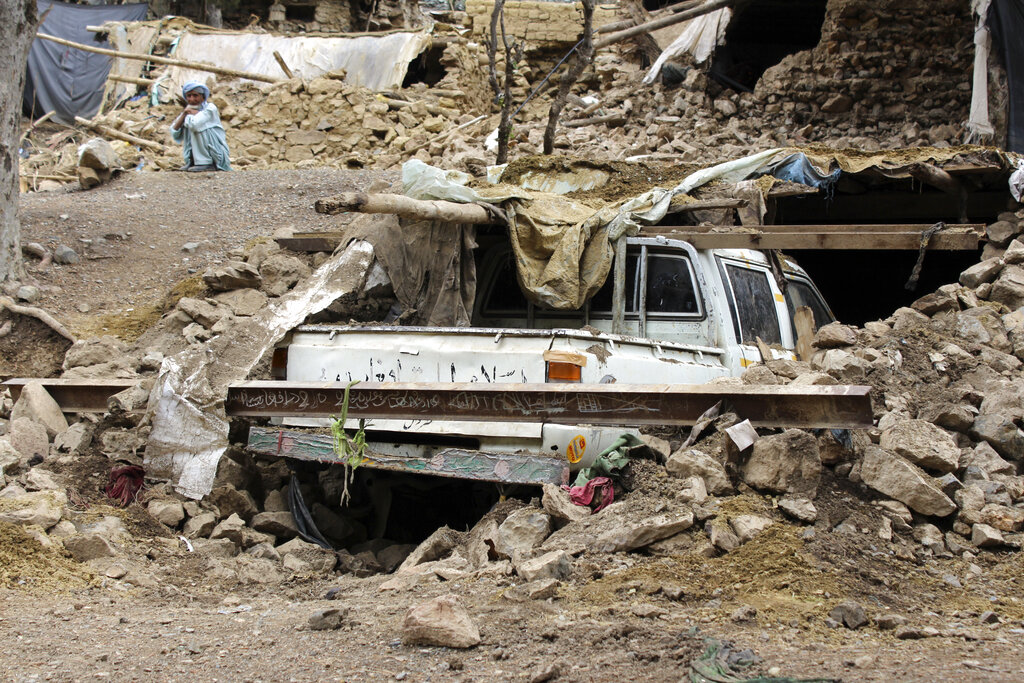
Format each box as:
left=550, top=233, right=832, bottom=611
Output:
left=225, top=381, right=873, bottom=428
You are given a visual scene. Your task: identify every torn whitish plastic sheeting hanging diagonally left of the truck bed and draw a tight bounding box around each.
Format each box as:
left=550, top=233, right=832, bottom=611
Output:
left=144, top=241, right=373, bottom=499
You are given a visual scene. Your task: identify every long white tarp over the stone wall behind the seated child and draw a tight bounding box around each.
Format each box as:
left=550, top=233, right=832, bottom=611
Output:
left=161, top=32, right=430, bottom=101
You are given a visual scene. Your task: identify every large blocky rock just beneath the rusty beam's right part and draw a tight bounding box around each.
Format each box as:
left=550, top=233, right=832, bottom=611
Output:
left=742, top=429, right=821, bottom=498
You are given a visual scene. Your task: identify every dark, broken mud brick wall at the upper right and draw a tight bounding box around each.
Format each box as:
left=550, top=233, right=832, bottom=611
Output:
left=757, top=0, right=974, bottom=137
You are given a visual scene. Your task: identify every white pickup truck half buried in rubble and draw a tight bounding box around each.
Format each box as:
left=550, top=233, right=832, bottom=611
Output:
left=250, top=236, right=834, bottom=482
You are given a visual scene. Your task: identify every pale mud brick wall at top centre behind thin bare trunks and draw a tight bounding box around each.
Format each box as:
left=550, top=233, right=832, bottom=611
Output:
left=466, top=0, right=620, bottom=44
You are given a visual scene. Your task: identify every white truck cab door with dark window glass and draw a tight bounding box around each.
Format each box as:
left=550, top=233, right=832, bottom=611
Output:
left=718, top=258, right=794, bottom=372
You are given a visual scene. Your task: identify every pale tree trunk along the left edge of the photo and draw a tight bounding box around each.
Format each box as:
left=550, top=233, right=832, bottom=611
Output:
left=0, top=0, right=39, bottom=282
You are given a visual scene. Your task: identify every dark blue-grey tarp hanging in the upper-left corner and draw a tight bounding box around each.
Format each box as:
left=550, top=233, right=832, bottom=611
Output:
left=23, top=0, right=148, bottom=125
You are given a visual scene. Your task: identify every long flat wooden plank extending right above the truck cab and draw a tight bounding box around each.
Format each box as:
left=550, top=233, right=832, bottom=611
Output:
left=641, top=231, right=979, bottom=251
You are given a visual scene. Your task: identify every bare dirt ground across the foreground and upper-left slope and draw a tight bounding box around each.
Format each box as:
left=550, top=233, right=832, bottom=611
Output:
left=0, top=169, right=1024, bottom=683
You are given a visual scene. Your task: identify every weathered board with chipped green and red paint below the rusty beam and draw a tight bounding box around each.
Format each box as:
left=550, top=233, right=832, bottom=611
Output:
left=248, top=427, right=567, bottom=485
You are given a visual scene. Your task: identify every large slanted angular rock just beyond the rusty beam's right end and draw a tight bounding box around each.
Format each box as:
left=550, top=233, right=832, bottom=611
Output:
left=860, top=445, right=956, bottom=517
